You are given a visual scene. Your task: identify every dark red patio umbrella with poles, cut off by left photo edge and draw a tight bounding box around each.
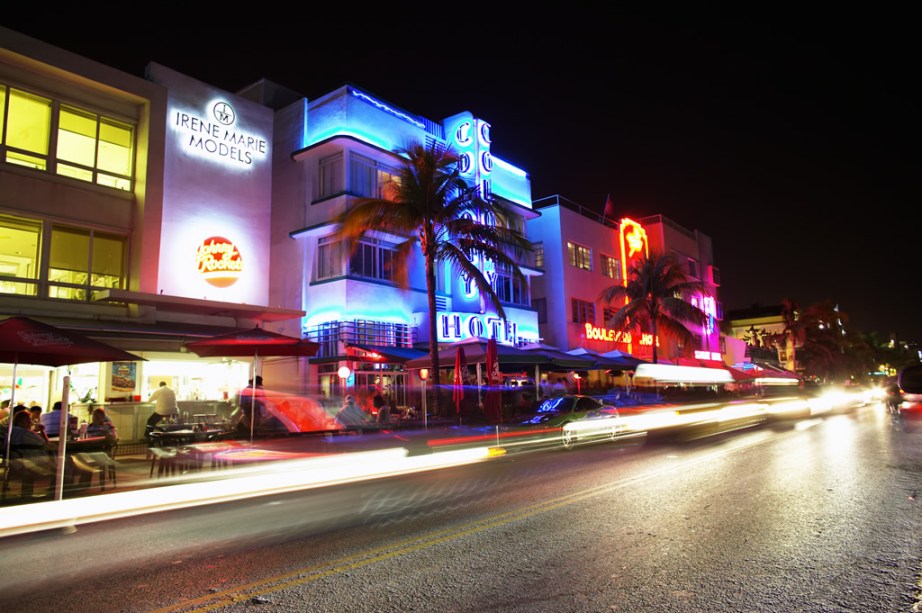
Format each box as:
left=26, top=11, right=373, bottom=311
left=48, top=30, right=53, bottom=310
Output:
left=0, top=316, right=146, bottom=500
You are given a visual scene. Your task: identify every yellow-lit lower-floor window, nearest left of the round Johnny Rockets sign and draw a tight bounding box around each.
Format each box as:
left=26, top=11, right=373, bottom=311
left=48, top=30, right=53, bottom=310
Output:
left=48, top=226, right=126, bottom=300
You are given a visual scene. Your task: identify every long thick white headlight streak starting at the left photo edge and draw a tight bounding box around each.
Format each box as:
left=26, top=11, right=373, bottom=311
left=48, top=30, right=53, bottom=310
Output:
left=0, top=447, right=492, bottom=537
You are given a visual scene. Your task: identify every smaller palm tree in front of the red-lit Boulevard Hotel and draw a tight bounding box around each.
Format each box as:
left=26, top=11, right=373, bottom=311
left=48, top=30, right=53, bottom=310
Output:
left=601, top=255, right=707, bottom=364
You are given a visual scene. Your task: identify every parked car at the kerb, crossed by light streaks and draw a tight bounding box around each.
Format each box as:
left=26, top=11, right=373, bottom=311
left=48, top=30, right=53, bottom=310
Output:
left=521, top=394, right=624, bottom=449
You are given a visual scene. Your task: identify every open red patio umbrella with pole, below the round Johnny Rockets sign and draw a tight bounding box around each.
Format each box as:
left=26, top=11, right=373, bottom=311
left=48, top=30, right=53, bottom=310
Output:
left=185, top=328, right=320, bottom=442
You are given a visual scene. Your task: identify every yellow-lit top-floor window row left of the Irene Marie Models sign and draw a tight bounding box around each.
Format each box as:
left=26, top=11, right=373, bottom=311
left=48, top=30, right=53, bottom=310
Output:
left=0, top=85, right=134, bottom=191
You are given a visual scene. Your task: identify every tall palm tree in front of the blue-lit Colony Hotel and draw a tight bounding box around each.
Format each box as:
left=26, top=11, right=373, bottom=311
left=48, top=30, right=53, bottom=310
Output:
left=337, top=143, right=532, bottom=415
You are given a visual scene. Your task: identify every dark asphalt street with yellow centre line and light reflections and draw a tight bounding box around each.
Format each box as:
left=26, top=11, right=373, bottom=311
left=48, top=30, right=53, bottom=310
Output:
left=0, top=404, right=922, bottom=613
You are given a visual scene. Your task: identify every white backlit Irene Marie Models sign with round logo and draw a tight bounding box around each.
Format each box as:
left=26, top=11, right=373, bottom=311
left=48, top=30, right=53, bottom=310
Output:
left=170, top=100, right=269, bottom=166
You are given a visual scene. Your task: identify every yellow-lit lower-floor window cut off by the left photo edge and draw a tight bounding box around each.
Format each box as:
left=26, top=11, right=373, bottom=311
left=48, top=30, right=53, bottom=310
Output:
left=0, top=215, right=42, bottom=296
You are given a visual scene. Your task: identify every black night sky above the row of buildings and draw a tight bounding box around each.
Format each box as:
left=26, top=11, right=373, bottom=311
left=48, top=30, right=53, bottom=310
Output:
left=0, top=10, right=922, bottom=340
